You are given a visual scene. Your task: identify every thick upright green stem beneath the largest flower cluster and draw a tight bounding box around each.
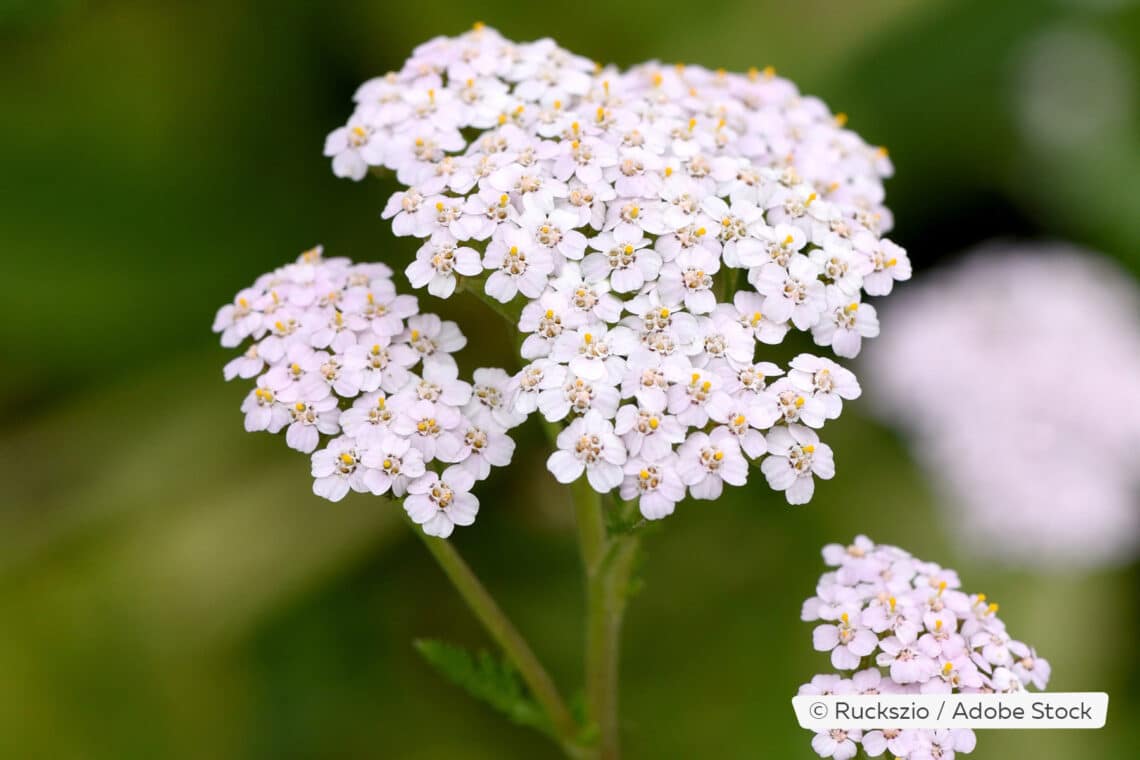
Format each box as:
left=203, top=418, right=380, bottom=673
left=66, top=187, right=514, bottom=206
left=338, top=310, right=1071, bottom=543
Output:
left=570, top=479, right=638, bottom=760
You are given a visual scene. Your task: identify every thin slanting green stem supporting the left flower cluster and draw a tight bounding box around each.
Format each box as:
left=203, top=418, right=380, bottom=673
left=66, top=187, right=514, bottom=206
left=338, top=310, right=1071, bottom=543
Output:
left=414, top=526, right=581, bottom=758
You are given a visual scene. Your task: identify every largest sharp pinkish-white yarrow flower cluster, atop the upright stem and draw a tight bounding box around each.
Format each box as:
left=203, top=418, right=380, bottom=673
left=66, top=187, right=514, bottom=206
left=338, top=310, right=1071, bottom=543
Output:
left=326, top=25, right=911, bottom=518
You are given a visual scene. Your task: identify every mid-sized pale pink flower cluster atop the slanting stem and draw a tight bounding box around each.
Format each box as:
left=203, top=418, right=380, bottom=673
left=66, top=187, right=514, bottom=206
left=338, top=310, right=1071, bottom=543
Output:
left=213, top=247, right=524, bottom=538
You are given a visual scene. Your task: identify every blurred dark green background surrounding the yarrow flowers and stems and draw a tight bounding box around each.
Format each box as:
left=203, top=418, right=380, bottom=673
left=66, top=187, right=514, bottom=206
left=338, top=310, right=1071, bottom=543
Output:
left=0, top=0, right=1140, bottom=760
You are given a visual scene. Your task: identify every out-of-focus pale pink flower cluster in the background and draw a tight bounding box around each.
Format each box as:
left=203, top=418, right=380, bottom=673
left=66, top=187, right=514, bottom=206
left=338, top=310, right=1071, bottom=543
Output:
left=865, top=245, right=1140, bottom=566
